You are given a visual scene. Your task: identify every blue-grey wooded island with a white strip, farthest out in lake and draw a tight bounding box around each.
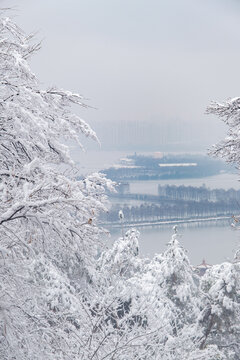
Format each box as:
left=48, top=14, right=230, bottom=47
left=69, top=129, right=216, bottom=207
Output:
left=103, top=152, right=231, bottom=181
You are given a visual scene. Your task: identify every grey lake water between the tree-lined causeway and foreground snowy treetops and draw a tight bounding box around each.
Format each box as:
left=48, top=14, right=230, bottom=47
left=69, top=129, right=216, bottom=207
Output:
left=110, top=220, right=240, bottom=265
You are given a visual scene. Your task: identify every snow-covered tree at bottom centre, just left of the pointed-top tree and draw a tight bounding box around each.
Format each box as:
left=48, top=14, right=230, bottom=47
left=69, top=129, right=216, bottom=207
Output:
left=82, top=229, right=155, bottom=359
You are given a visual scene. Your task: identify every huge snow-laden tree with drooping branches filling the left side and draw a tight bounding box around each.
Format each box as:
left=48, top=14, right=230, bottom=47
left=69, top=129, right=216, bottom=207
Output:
left=0, top=14, right=110, bottom=360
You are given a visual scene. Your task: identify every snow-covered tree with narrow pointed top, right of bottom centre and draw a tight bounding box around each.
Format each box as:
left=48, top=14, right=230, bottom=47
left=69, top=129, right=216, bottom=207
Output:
left=139, top=229, right=202, bottom=359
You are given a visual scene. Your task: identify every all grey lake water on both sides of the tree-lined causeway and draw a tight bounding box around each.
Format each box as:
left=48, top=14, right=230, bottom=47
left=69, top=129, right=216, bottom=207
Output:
left=106, top=174, right=240, bottom=265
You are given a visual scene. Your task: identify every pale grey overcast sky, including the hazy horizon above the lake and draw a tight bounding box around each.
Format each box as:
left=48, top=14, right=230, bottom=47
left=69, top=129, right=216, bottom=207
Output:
left=1, top=0, right=240, bottom=151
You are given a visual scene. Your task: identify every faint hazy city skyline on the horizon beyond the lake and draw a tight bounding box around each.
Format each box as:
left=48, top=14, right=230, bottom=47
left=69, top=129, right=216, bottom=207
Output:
left=84, top=120, right=224, bottom=154
